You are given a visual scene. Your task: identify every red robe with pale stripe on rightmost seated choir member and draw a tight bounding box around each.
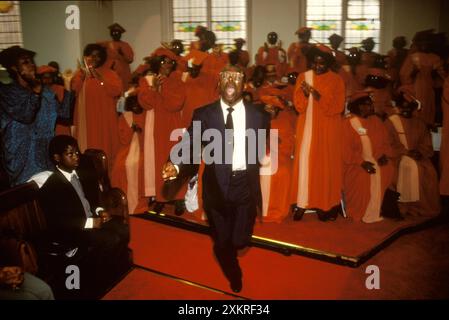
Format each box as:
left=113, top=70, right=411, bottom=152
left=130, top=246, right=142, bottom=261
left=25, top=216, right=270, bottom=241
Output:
left=385, top=114, right=440, bottom=216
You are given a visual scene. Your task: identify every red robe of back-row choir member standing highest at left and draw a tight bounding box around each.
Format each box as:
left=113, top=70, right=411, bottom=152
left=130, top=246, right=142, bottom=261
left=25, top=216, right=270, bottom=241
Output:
left=101, top=40, right=134, bottom=90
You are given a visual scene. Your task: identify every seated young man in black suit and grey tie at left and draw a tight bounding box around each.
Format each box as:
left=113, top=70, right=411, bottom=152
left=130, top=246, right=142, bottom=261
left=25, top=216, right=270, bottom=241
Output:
left=39, top=135, right=129, bottom=288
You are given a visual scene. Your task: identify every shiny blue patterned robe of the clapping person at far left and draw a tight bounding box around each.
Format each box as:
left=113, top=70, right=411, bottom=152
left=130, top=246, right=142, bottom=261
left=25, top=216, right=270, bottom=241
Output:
left=0, top=81, right=73, bottom=186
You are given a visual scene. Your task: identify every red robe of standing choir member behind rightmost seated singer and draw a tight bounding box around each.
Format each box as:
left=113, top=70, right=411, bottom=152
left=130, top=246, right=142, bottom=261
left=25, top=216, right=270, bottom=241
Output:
left=400, top=52, right=442, bottom=125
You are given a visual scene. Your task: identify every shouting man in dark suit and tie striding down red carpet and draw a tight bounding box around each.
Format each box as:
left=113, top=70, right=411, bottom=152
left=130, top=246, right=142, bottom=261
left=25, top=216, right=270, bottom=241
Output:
left=162, top=66, right=269, bottom=292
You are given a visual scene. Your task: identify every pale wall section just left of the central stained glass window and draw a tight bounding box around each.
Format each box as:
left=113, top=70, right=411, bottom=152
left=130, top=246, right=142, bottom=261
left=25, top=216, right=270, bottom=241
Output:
left=113, top=0, right=162, bottom=69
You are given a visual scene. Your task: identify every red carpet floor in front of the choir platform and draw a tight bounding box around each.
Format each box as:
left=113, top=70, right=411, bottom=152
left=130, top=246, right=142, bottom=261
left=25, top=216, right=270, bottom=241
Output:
left=104, top=218, right=449, bottom=300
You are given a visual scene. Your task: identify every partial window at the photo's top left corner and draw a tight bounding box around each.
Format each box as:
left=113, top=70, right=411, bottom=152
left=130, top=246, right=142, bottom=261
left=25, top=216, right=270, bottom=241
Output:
left=0, top=1, right=23, bottom=50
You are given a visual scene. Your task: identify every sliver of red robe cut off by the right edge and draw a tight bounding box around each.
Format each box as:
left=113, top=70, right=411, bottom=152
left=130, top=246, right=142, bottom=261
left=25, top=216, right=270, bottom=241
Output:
left=440, top=77, right=449, bottom=196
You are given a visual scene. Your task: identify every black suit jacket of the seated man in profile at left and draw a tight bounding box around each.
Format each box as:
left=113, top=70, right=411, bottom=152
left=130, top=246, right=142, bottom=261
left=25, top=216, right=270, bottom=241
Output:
left=39, top=157, right=100, bottom=242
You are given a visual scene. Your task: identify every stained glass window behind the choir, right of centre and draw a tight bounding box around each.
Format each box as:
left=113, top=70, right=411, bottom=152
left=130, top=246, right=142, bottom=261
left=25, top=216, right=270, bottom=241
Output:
left=306, top=0, right=380, bottom=51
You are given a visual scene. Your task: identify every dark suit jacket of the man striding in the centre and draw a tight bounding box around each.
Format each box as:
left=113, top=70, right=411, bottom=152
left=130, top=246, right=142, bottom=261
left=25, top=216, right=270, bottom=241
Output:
left=172, top=100, right=269, bottom=210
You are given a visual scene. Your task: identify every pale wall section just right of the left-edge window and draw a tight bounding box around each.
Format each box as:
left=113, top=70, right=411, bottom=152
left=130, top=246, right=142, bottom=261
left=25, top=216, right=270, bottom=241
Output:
left=20, top=1, right=80, bottom=70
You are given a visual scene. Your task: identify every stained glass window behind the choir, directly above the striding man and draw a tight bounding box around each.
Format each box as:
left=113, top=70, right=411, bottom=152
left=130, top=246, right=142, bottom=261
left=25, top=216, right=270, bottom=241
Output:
left=172, top=0, right=247, bottom=51
